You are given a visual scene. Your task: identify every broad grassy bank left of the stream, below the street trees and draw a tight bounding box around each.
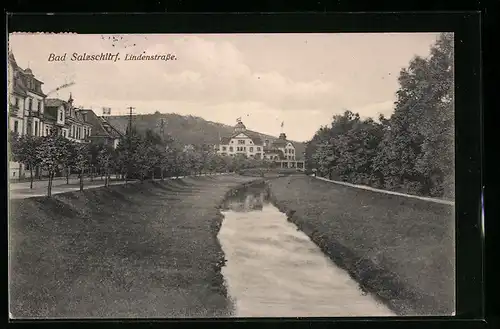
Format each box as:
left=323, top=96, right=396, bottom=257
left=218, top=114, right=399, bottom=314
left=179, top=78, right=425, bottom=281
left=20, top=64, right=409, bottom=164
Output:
left=9, top=175, right=254, bottom=318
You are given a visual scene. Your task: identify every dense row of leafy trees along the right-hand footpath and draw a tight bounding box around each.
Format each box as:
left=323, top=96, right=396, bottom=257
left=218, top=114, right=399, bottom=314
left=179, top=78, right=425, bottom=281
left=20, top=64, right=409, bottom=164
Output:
left=306, top=33, right=454, bottom=198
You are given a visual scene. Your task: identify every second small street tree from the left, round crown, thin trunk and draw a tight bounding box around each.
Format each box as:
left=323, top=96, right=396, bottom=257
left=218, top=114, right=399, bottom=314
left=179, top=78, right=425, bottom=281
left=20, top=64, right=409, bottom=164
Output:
left=35, top=134, right=66, bottom=197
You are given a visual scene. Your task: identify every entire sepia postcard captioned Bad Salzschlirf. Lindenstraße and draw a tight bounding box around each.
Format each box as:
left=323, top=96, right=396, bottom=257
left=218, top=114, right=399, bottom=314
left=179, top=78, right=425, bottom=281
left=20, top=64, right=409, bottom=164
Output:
left=6, top=32, right=456, bottom=319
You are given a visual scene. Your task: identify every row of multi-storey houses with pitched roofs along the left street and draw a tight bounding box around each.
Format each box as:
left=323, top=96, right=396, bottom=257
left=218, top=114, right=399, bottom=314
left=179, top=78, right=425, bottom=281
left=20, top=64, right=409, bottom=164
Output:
left=7, top=51, right=122, bottom=179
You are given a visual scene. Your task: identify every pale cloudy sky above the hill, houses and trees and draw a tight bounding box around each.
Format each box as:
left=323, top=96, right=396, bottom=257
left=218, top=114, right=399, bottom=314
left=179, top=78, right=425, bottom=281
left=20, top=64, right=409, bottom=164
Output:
left=9, top=33, right=438, bottom=141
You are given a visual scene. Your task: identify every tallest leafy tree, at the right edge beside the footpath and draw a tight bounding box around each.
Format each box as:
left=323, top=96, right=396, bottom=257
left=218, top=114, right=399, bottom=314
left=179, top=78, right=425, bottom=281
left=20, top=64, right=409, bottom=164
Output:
left=375, top=33, right=454, bottom=197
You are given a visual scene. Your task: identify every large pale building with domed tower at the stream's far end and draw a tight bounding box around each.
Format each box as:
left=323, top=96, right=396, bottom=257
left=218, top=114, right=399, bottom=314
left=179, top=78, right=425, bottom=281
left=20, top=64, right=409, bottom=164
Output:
left=216, top=120, right=304, bottom=169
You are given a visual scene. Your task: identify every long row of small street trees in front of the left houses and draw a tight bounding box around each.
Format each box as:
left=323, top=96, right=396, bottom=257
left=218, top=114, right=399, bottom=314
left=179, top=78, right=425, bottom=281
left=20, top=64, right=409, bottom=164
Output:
left=10, top=130, right=270, bottom=196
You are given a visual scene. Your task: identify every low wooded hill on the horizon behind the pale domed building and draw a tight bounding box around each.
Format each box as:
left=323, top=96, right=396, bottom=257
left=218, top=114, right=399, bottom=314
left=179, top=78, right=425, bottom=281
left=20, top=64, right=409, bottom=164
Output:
left=107, top=112, right=305, bottom=159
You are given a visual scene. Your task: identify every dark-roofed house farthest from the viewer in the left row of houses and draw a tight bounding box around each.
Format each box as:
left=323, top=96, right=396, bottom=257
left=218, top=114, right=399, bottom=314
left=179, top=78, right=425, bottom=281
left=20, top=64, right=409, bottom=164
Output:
left=78, top=109, right=123, bottom=148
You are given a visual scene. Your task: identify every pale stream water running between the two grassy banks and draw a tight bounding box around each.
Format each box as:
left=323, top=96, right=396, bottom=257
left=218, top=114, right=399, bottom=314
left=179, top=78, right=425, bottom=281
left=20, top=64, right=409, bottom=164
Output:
left=219, top=183, right=394, bottom=317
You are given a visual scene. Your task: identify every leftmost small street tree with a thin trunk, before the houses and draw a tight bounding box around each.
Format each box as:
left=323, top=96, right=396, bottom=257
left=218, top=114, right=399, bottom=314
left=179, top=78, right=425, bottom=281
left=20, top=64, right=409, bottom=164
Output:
left=10, top=135, right=40, bottom=189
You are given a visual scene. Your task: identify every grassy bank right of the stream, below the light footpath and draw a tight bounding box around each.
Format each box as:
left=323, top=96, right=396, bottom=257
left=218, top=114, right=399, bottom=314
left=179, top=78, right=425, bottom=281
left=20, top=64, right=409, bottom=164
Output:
left=270, top=176, right=455, bottom=315
